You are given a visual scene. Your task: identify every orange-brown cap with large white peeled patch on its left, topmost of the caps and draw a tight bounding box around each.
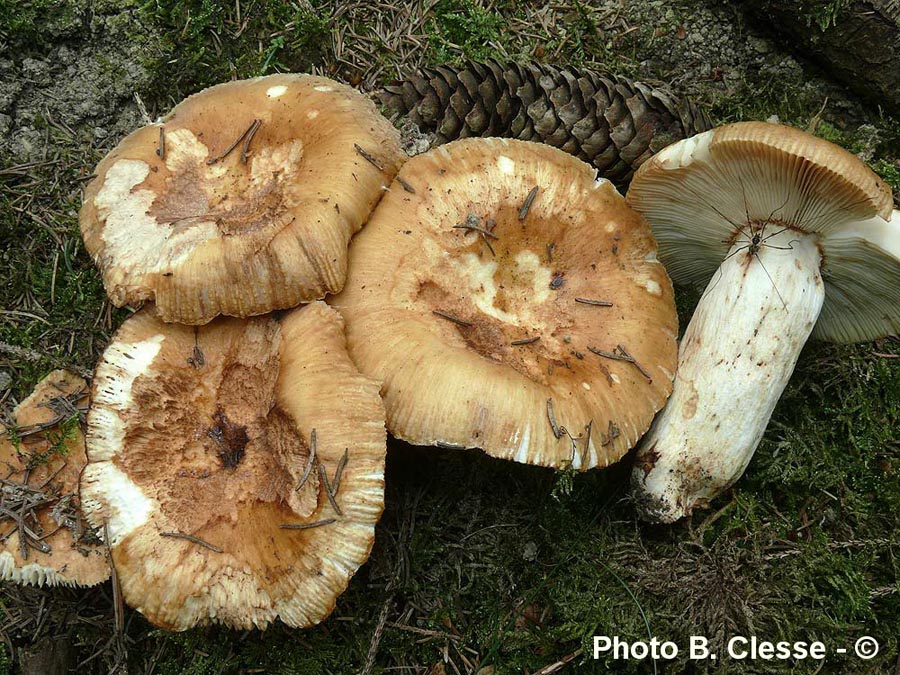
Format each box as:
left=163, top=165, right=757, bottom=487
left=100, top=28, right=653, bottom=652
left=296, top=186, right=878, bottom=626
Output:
left=79, top=75, right=405, bottom=324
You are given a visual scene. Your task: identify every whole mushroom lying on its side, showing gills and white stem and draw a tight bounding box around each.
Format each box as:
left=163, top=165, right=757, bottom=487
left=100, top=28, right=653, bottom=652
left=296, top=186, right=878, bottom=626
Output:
left=627, top=122, right=900, bottom=522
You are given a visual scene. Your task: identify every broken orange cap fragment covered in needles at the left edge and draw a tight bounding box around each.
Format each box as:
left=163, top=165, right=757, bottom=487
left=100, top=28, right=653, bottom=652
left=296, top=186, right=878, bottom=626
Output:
left=0, top=370, right=109, bottom=586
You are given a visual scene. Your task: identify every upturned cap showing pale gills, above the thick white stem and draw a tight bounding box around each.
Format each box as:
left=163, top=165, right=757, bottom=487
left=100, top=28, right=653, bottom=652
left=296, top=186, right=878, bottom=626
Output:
left=627, top=122, right=900, bottom=342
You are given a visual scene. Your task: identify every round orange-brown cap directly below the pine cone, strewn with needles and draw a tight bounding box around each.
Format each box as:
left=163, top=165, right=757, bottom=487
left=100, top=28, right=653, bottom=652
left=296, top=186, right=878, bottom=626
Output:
left=332, top=139, right=677, bottom=469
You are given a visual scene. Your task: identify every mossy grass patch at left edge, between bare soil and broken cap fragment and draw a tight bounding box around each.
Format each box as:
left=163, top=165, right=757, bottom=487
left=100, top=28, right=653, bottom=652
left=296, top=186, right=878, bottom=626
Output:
left=0, top=146, right=126, bottom=397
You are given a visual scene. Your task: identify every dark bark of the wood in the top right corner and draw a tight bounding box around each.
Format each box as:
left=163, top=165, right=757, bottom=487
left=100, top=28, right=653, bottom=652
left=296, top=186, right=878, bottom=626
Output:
left=744, top=0, right=900, bottom=116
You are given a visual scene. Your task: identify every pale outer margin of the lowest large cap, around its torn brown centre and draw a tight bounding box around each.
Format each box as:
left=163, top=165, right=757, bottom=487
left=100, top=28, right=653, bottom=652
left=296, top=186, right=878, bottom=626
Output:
left=82, top=303, right=385, bottom=630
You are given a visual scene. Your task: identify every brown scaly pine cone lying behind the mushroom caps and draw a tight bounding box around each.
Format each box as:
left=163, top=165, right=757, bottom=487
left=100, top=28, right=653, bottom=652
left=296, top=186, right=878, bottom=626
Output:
left=380, top=61, right=711, bottom=184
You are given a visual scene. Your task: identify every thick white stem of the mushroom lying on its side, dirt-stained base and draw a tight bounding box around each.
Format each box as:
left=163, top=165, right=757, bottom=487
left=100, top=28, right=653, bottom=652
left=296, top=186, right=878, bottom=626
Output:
left=632, top=230, right=825, bottom=522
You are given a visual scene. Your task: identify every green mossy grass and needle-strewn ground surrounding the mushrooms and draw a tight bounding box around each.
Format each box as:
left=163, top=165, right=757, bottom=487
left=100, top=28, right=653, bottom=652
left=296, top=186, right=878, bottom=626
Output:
left=0, top=0, right=900, bottom=675
